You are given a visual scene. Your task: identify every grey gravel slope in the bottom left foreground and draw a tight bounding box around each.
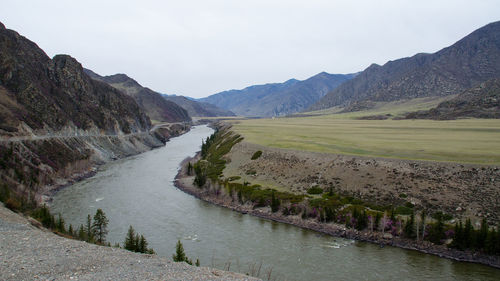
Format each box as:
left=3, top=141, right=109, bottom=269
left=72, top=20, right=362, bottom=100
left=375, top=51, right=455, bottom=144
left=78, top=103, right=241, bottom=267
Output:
left=0, top=203, right=259, bottom=280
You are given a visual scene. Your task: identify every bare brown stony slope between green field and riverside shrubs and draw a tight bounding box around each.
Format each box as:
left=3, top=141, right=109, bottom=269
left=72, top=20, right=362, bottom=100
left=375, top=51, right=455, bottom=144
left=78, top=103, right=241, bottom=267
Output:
left=224, top=142, right=500, bottom=225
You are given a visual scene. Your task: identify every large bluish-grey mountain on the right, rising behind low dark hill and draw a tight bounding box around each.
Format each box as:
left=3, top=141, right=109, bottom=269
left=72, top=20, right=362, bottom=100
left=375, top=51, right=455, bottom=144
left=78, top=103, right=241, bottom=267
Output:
left=309, top=22, right=500, bottom=111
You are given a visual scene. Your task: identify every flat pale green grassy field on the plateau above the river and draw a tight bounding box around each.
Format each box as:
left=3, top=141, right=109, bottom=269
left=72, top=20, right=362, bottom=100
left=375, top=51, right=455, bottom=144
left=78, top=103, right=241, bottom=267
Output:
left=234, top=114, right=500, bottom=165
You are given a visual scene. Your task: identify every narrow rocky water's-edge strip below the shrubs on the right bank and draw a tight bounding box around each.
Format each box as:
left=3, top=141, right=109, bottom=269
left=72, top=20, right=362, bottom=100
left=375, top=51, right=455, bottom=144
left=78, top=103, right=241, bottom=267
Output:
left=174, top=153, right=500, bottom=269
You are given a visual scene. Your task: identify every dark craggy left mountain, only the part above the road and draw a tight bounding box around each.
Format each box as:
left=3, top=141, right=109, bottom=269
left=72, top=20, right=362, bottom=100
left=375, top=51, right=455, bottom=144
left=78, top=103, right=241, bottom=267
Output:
left=0, top=22, right=151, bottom=134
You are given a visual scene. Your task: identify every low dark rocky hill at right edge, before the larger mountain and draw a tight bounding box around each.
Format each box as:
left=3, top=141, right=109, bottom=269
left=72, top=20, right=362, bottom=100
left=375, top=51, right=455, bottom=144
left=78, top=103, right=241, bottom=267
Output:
left=406, top=78, right=500, bottom=120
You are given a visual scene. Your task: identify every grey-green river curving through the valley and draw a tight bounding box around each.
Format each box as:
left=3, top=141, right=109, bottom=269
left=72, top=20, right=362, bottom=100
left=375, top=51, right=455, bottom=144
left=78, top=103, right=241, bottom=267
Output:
left=51, top=126, right=500, bottom=280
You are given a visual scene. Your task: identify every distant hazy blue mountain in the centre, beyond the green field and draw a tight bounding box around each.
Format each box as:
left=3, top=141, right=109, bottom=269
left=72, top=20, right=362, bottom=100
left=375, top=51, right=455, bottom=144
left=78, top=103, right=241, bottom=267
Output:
left=200, top=72, right=355, bottom=117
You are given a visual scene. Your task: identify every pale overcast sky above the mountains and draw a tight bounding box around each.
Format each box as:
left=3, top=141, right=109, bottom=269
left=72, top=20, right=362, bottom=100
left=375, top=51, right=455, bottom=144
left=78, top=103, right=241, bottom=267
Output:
left=0, top=0, right=500, bottom=97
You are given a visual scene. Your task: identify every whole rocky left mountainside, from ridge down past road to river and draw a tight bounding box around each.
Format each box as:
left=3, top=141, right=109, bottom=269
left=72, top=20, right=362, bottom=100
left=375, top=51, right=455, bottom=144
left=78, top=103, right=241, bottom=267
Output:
left=0, top=21, right=186, bottom=201
